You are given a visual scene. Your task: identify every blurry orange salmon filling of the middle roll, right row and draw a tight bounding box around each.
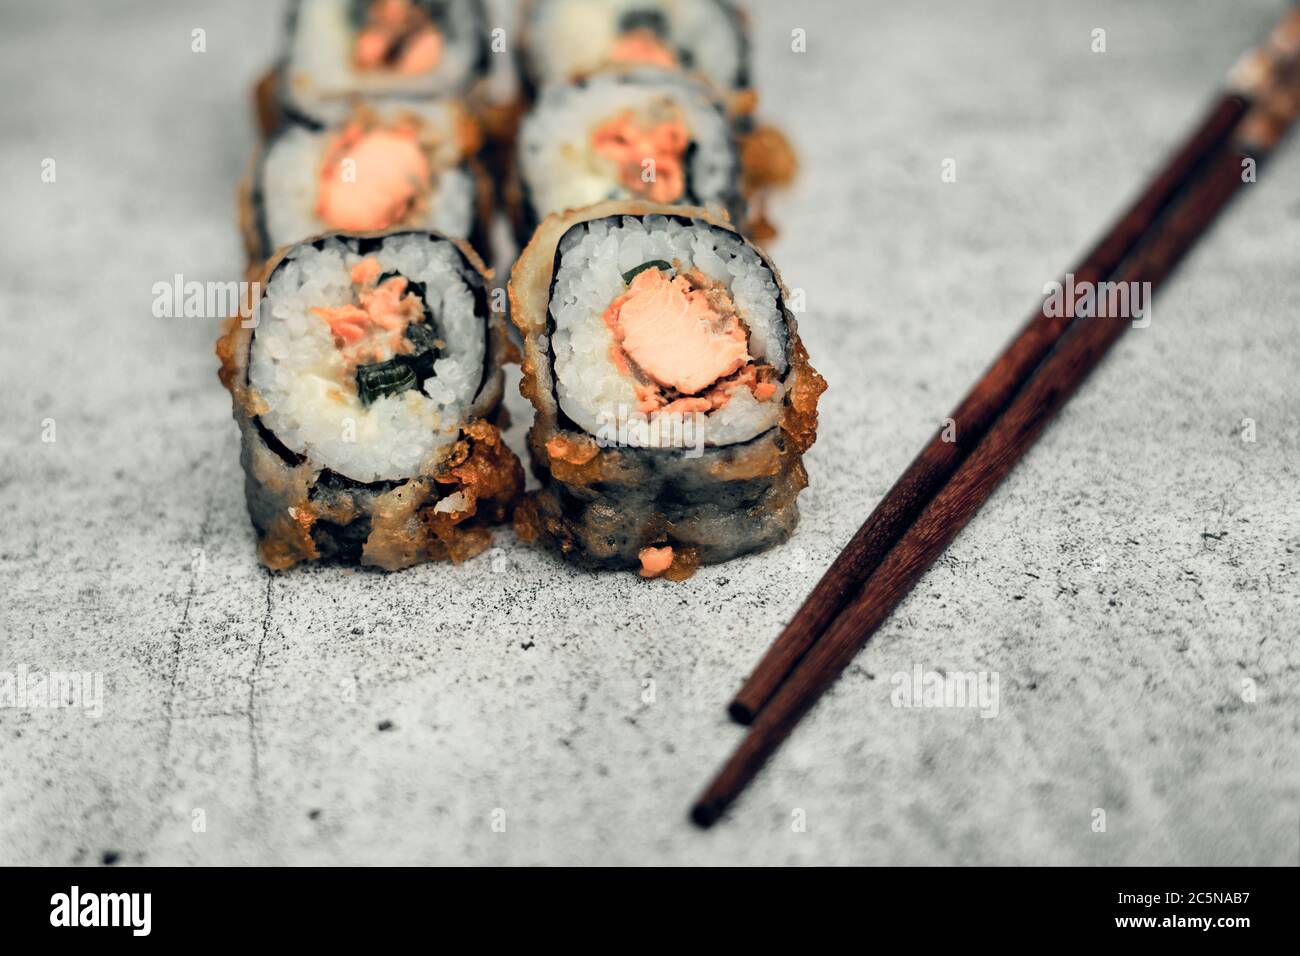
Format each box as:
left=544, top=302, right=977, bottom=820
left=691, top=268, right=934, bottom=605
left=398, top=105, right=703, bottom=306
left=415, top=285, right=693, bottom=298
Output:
left=592, top=109, right=690, bottom=203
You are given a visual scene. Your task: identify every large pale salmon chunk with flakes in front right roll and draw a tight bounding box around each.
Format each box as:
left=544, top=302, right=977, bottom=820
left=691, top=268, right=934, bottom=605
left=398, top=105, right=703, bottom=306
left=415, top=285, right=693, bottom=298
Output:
left=602, top=263, right=776, bottom=415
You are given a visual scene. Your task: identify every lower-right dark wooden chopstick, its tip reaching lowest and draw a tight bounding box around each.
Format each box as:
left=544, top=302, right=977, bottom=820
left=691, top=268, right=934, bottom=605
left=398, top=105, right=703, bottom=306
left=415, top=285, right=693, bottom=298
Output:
left=692, top=27, right=1300, bottom=826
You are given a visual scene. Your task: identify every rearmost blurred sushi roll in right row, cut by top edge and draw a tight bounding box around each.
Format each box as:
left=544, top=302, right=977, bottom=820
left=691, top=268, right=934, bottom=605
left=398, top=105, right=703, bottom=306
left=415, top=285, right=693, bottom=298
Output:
left=520, top=0, right=750, bottom=112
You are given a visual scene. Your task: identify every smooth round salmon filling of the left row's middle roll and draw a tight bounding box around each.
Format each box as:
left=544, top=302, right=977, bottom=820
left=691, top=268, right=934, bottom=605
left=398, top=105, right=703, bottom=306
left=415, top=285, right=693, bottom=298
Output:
left=316, top=121, right=433, bottom=232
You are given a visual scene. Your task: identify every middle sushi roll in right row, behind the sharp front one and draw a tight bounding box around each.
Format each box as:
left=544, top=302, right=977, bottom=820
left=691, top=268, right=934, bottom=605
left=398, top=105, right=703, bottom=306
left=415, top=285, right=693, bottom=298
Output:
left=511, top=68, right=744, bottom=243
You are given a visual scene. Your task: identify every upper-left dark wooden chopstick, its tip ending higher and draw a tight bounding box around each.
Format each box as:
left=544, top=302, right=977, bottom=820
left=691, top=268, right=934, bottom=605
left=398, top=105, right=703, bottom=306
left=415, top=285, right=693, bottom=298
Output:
left=728, top=12, right=1300, bottom=724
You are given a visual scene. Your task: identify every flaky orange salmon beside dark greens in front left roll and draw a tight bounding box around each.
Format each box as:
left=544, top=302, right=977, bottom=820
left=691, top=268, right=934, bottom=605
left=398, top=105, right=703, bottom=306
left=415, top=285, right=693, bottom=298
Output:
left=312, top=256, right=425, bottom=372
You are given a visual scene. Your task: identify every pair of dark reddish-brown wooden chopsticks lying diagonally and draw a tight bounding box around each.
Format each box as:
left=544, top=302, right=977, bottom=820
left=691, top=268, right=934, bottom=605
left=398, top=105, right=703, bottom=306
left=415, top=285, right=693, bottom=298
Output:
left=692, top=9, right=1300, bottom=826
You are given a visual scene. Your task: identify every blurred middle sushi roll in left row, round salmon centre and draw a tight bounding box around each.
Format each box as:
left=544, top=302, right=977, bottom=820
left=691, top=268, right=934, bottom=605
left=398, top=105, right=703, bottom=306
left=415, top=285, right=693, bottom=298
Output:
left=241, top=101, right=493, bottom=264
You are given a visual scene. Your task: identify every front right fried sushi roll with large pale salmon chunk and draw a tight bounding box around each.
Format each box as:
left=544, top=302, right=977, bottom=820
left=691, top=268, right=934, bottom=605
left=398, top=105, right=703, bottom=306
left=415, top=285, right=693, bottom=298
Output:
left=510, top=202, right=826, bottom=579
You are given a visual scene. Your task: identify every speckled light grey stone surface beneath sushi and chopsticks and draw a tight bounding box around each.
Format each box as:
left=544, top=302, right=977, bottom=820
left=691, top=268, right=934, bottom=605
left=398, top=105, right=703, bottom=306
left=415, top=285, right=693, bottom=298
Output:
left=0, top=0, right=1300, bottom=865
